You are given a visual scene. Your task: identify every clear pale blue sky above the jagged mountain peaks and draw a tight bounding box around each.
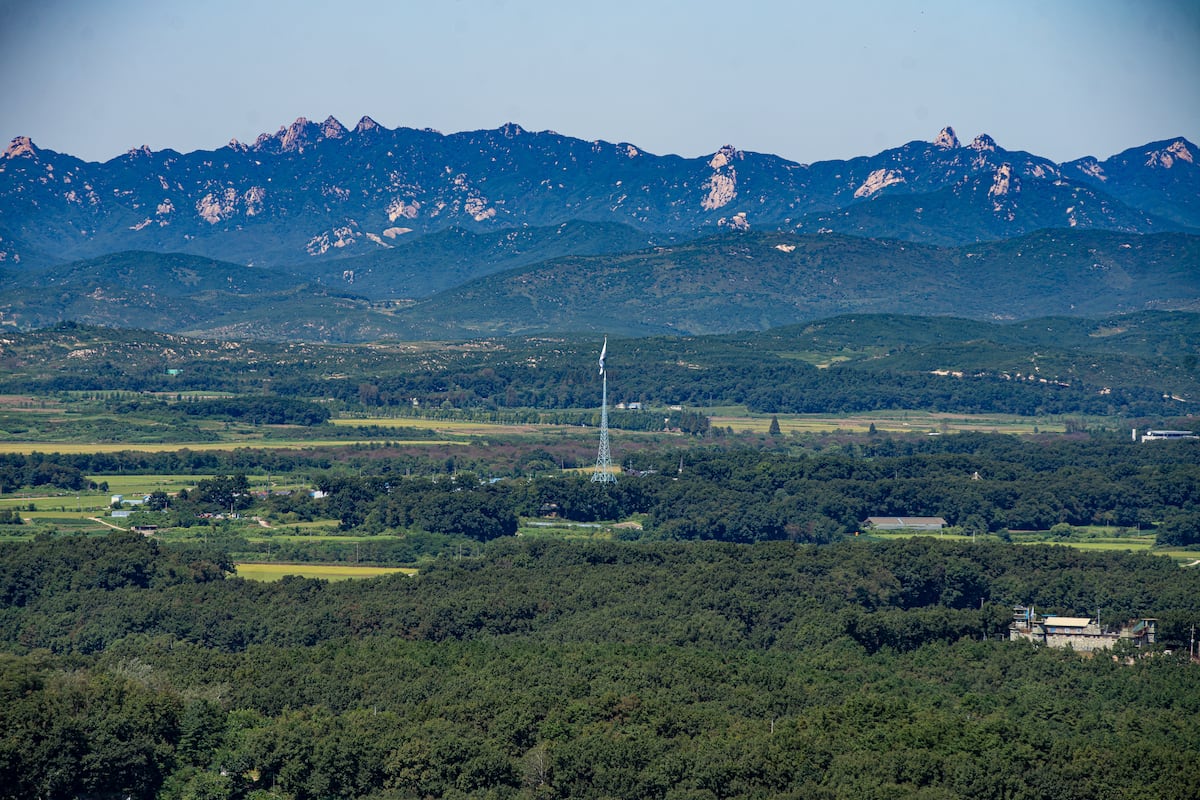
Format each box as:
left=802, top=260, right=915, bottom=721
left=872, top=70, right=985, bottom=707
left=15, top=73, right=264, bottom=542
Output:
left=0, top=0, right=1200, bottom=162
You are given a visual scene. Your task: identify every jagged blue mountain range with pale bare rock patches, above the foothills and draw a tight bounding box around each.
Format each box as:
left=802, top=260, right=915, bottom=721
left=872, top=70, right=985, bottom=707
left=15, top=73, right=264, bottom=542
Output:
left=0, top=116, right=1200, bottom=270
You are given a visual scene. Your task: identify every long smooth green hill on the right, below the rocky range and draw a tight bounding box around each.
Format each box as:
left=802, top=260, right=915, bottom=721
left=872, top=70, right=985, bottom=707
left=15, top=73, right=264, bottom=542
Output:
left=381, top=230, right=1200, bottom=338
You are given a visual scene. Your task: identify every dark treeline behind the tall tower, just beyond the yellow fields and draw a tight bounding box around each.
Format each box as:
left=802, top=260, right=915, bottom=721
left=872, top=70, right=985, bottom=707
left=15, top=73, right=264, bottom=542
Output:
left=275, top=353, right=1180, bottom=416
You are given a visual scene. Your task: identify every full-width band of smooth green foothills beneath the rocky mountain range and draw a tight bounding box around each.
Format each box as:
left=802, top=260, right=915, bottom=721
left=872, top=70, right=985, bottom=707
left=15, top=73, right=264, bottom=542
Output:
left=0, top=224, right=1200, bottom=342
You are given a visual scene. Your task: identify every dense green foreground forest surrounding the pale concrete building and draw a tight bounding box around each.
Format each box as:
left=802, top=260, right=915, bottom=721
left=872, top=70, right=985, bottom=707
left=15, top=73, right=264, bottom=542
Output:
left=0, top=535, right=1200, bottom=800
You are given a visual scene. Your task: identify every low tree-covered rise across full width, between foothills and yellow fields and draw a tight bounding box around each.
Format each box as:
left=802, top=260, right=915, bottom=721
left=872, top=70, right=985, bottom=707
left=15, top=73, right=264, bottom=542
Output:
left=0, top=312, right=1200, bottom=417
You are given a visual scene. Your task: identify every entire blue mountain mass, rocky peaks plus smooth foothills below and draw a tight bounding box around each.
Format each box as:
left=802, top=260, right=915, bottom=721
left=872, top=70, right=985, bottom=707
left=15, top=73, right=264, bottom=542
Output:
left=0, top=118, right=1200, bottom=341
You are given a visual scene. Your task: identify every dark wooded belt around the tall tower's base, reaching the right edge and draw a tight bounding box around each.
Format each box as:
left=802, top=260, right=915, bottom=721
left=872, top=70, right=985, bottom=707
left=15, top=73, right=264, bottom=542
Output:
left=297, top=434, right=1200, bottom=545
